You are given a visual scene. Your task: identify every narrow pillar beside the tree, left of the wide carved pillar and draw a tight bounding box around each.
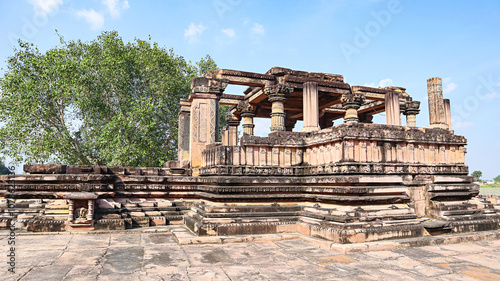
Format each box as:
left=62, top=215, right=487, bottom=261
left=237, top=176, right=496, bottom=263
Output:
left=178, top=99, right=191, bottom=167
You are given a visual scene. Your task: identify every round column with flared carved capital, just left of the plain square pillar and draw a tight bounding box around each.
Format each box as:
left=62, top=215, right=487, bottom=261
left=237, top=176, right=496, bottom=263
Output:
left=264, top=84, right=293, bottom=132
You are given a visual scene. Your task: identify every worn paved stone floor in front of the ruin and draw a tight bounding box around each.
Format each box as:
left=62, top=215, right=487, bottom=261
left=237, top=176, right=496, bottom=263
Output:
left=0, top=230, right=500, bottom=281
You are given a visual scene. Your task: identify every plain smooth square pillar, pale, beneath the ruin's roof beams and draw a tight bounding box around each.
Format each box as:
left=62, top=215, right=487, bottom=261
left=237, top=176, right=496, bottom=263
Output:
left=302, top=82, right=319, bottom=132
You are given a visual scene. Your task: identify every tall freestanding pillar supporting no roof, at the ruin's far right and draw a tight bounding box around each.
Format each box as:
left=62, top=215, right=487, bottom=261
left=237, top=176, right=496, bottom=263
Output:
left=427, top=77, right=448, bottom=129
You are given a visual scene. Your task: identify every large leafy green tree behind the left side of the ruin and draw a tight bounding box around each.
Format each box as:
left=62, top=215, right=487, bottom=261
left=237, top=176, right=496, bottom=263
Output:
left=0, top=31, right=224, bottom=166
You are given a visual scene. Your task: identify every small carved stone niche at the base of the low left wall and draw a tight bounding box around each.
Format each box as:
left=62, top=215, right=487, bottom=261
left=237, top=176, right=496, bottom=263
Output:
left=64, top=192, right=98, bottom=230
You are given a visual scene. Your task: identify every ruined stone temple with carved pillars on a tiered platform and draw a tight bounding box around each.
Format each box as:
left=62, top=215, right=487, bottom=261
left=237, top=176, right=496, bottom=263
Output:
left=0, top=67, right=500, bottom=243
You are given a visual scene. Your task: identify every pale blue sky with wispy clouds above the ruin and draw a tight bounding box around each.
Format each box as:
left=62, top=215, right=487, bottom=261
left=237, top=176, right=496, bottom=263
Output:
left=0, top=0, right=500, bottom=179
